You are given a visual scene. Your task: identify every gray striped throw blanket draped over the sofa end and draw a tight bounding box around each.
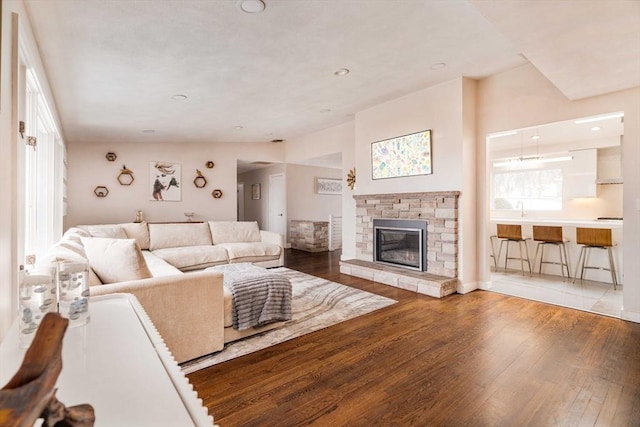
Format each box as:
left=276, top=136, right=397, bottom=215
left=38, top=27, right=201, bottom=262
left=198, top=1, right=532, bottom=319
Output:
left=213, top=263, right=291, bottom=331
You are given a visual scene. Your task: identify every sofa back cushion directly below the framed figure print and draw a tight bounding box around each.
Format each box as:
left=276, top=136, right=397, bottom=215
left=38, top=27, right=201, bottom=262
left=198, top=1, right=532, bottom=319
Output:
left=149, top=222, right=212, bottom=251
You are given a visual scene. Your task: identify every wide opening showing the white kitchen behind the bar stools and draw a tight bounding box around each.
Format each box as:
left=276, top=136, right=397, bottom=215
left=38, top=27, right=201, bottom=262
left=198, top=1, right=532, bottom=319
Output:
left=486, top=113, right=624, bottom=318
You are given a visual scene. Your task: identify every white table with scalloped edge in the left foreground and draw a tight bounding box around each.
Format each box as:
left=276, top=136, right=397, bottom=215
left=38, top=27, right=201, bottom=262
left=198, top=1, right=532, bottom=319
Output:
left=0, top=294, right=213, bottom=427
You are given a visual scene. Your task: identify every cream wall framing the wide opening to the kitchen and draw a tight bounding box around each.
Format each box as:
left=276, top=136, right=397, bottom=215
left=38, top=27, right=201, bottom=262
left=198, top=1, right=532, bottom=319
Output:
left=476, top=65, right=640, bottom=322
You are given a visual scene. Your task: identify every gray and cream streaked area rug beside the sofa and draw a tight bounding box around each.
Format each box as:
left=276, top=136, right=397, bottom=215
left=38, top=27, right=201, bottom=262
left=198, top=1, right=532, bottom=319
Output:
left=180, top=267, right=396, bottom=374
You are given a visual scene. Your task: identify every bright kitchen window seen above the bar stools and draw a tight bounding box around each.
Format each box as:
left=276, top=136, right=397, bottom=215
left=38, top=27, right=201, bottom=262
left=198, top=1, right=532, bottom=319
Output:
left=491, top=168, right=562, bottom=211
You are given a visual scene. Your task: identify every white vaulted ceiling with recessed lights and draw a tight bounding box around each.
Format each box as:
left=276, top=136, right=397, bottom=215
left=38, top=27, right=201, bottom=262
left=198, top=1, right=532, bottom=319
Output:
left=25, top=0, right=640, bottom=143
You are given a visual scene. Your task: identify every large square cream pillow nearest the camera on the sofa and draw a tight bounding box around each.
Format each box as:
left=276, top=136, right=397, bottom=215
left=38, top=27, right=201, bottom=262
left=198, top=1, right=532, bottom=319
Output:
left=82, top=237, right=152, bottom=284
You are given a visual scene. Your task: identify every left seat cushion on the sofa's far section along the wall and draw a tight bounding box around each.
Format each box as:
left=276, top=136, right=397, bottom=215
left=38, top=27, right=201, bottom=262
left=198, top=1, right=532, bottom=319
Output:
left=152, top=245, right=229, bottom=271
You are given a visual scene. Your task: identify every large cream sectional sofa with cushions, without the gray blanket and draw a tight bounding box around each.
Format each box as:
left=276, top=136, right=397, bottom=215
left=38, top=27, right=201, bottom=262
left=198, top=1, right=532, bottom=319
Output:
left=38, top=221, right=284, bottom=363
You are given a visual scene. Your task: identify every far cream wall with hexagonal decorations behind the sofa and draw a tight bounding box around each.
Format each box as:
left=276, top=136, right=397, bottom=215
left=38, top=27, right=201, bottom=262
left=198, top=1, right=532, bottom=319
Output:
left=65, top=143, right=284, bottom=228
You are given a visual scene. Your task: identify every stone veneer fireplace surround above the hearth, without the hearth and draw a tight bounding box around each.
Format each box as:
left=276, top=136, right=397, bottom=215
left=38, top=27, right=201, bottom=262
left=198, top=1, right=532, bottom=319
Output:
left=353, top=191, right=460, bottom=278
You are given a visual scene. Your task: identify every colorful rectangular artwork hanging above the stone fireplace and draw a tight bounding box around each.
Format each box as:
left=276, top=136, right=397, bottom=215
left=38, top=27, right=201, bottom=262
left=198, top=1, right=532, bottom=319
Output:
left=371, top=130, right=433, bottom=179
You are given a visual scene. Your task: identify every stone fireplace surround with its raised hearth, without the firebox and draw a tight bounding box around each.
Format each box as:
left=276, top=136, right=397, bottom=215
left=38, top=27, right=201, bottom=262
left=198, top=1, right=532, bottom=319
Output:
left=340, top=191, right=460, bottom=298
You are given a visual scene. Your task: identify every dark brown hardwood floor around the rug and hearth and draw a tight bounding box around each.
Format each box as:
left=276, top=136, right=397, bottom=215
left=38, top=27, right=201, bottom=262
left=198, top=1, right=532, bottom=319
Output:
left=188, top=250, right=640, bottom=427
